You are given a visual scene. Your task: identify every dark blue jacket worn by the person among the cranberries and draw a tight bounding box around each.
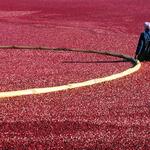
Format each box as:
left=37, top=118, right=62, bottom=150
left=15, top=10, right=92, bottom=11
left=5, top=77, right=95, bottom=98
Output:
left=136, top=30, right=150, bottom=55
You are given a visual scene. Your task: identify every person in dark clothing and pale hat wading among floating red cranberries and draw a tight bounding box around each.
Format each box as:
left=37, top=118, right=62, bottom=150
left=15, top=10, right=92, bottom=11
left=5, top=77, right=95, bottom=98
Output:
left=135, top=22, right=150, bottom=61
